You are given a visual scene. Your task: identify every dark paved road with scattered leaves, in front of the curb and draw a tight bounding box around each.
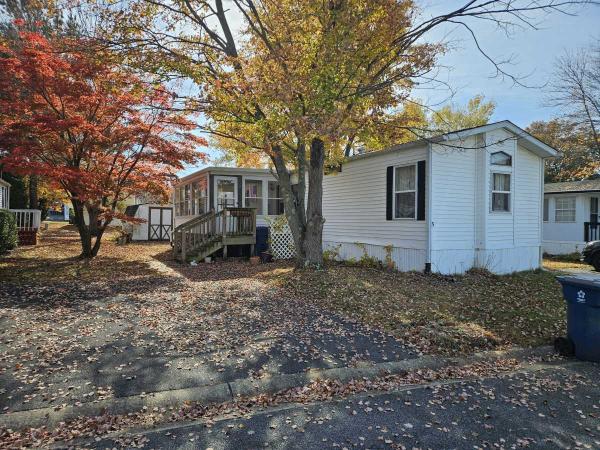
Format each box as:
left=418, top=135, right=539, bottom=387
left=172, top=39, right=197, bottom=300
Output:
left=91, top=362, right=600, bottom=450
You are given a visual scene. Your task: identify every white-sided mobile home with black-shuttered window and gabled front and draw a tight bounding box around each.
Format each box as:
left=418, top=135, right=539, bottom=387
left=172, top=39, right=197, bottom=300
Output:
left=323, top=121, right=557, bottom=274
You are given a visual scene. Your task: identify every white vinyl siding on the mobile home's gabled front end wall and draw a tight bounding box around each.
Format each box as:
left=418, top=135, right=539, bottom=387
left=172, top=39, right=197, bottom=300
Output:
left=431, top=130, right=543, bottom=273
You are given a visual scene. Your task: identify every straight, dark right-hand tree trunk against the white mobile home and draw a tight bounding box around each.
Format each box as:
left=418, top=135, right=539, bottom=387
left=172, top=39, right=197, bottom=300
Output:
left=304, top=138, right=325, bottom=268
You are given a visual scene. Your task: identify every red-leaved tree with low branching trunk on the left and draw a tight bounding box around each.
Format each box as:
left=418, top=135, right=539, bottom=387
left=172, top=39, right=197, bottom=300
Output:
left=0, top=32, right=206, bottom=258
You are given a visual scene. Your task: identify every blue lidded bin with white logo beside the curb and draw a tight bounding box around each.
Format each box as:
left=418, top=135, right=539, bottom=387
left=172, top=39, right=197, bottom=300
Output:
left=557, top=276, right=600, bottom=362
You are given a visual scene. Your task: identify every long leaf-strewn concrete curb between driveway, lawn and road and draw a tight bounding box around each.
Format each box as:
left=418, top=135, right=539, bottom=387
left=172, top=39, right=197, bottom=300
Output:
left=0, top=346, right=554, bottom=429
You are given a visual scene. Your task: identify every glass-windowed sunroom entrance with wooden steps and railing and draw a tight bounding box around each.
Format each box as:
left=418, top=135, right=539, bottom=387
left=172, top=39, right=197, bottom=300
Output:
left=173, top=167, right=284, bottom=261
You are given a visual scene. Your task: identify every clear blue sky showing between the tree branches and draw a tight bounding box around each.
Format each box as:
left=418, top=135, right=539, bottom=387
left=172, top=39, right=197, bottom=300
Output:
left=180, top=0, right=600, bottom=176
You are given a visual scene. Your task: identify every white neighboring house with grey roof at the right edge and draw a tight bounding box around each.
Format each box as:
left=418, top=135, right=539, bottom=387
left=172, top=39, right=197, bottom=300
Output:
left=543, top=179, right=600, bottom=255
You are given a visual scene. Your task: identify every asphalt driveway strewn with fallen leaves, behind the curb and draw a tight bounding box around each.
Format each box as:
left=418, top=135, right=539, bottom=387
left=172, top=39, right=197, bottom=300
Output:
left=0, top=262, right=417, bottom=413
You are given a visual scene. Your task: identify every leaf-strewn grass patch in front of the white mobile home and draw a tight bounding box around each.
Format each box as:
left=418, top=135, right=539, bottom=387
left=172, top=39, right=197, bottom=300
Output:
left=260, top=264, right=565, bottom=354
